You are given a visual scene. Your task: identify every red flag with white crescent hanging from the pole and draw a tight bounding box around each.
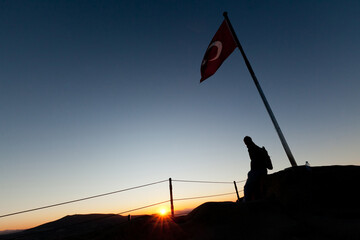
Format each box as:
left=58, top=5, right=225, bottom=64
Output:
left=200, top=20, right=236, bottom=82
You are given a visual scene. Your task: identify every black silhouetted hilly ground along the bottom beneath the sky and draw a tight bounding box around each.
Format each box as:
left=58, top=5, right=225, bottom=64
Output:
left=0, top=166, right=360, bottom=240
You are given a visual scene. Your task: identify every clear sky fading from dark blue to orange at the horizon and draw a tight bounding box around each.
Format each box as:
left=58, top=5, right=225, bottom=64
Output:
left=0, top=0, right=360, bottom=230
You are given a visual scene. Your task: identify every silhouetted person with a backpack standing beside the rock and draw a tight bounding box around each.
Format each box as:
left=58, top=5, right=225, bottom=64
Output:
left=244, top=136, right=272, bottom=202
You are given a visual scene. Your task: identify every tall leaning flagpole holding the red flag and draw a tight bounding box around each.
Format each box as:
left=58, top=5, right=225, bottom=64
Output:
left=223, top=12, right=297, bottom=167
